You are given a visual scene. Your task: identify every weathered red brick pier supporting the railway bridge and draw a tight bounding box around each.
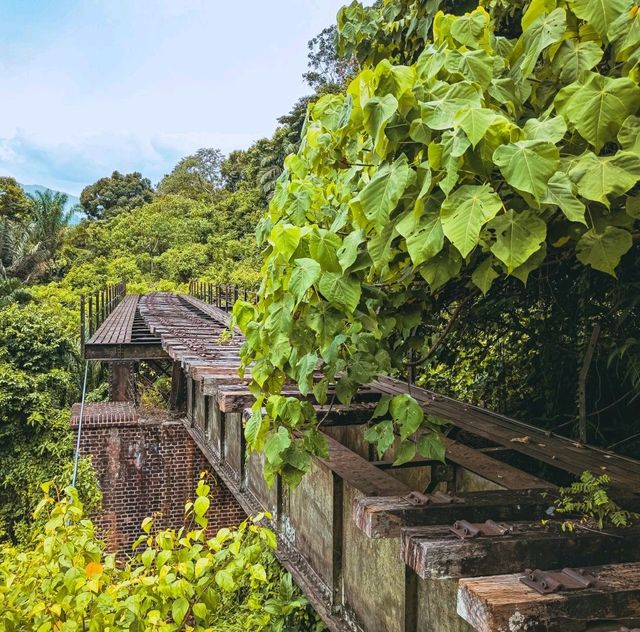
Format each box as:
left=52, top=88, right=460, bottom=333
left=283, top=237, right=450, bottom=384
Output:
left=71, top=402, right=246, bottom=551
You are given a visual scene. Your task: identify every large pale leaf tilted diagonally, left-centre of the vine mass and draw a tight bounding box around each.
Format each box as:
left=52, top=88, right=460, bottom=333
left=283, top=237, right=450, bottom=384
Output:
left=352, top=154, right=413, bottom=226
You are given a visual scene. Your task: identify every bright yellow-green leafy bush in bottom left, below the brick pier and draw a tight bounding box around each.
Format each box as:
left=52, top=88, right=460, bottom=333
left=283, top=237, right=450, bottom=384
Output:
left=0, top=480, right=324, bottom=632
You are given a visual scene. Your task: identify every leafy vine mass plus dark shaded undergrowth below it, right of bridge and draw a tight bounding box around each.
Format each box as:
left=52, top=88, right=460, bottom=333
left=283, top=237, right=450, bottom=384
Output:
left=235, top=0, right=640, bottom=483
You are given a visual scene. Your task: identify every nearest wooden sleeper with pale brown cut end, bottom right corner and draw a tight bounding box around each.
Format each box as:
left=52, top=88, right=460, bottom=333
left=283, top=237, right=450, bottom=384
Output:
left=457, top=563, right=640, bottom=632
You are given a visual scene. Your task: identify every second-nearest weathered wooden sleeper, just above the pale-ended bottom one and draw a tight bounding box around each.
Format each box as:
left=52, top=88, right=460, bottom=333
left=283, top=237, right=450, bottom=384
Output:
left=401, top=521, right=640, bottom=579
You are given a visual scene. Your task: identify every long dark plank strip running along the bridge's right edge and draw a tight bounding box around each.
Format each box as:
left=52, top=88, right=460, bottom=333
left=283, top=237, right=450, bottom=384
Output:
left=373, top=377, right=640, bottom=490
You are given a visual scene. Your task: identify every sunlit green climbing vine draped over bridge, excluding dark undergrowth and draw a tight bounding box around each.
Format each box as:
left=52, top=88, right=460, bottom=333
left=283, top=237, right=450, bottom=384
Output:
left=234, top=0, right=640, bottom=483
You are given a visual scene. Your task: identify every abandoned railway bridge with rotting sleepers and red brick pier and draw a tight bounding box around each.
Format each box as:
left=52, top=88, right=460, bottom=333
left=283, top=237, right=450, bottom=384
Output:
left=72, top=284, right=640, bottom=632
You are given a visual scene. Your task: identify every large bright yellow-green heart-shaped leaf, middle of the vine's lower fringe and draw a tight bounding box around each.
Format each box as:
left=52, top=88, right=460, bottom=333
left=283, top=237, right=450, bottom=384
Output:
left=441, top=184, right=502, bottom=257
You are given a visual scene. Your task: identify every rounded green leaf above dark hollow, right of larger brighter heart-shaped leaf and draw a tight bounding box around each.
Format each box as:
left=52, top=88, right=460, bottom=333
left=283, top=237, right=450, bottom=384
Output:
left=489, top=209, right=547, bottom=274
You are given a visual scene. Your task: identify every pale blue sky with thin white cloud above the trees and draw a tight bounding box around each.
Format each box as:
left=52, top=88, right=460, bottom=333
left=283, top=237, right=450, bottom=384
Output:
left=0, top=0, right=345, bottom=195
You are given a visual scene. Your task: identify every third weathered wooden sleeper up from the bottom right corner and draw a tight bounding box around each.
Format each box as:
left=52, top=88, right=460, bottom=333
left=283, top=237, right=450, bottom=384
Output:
left=353, top=489, right=551, bottom=538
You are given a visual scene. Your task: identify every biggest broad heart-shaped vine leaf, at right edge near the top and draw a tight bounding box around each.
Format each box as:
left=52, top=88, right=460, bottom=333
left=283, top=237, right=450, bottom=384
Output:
left=556, top=73, right=640, bottom=152
